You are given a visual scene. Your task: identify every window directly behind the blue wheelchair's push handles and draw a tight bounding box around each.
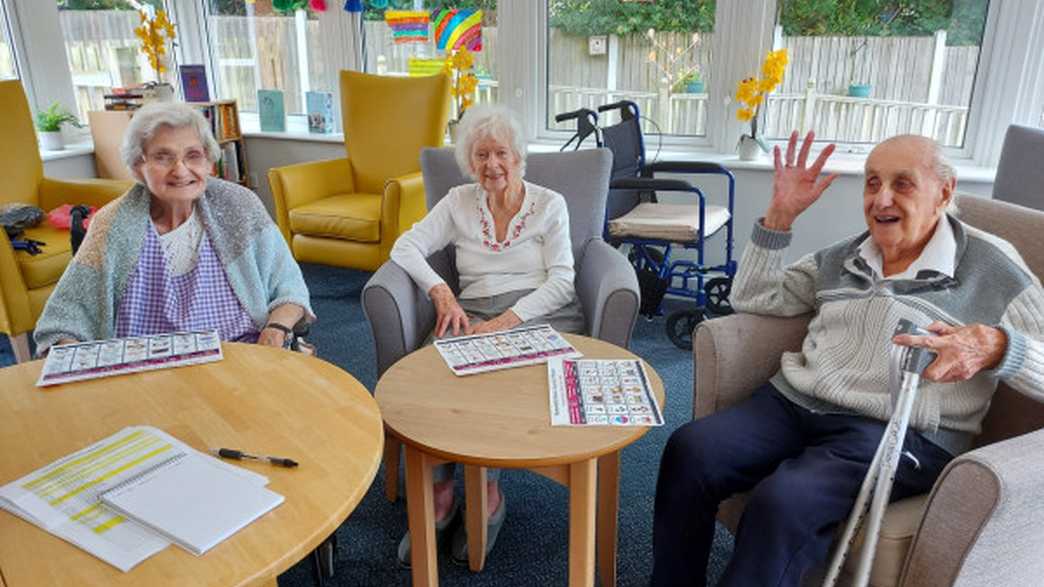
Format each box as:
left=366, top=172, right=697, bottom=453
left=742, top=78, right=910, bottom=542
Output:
left=546, top=0, right=715, bottom=136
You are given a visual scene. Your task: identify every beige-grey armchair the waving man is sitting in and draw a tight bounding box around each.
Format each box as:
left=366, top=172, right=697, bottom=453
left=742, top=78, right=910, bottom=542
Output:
left=692, top=196, right=1044, bottom=587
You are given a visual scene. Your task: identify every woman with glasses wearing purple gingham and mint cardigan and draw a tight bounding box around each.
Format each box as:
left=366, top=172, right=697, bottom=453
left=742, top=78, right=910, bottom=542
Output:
left=33, top=103, right=314, bottom=353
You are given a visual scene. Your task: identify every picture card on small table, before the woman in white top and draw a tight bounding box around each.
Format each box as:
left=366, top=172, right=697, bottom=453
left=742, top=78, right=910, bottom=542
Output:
left=434, top=324, right=584, bottom=375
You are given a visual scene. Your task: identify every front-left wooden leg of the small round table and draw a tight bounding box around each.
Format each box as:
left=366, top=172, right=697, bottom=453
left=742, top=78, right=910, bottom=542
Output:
left=406, top=444, right=438, bottom=587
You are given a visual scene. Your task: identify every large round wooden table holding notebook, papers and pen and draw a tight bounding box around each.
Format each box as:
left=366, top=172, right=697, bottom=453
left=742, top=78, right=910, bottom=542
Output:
left=0, top=344, right=384, bottom=587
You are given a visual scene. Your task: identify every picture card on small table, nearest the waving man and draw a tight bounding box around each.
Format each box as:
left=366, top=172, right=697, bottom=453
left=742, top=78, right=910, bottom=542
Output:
left=547, top=359, right=663, bottom=426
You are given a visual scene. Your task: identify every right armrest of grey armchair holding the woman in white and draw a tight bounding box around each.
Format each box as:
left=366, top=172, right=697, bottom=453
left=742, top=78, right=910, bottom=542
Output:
left=576, top=238, right=641, bottom=349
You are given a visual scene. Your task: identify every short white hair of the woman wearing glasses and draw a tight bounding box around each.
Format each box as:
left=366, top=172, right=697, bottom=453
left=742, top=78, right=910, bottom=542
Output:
left=120, top=102, right=221, bottom=180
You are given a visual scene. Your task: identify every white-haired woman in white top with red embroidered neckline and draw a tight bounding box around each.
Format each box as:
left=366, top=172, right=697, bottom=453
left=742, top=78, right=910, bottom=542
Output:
left=392, top=105, right=584, bottom=564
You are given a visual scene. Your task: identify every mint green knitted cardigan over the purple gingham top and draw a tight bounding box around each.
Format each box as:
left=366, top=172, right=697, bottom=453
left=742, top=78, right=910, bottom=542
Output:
left=33, top=178, right=315, bottom=353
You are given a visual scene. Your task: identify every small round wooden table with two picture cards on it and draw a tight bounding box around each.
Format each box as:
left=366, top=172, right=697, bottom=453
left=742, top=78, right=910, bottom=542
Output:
left=376, top=334, right=664, bottom=587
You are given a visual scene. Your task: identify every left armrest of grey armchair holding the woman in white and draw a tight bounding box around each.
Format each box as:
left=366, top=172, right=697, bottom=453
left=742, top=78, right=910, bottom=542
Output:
left=362, top=245, right=457, bottom=377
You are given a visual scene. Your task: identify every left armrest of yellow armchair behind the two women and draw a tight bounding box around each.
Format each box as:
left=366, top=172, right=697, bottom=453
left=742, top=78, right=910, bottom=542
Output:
left=268, top=157, right=355, bottom=243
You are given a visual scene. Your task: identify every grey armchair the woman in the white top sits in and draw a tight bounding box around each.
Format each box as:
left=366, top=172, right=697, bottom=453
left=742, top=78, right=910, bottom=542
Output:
left=362, top=148, right=639, bottom=500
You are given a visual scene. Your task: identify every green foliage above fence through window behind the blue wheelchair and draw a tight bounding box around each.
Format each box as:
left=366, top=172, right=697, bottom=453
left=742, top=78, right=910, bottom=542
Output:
left=548, top=0, right=715, bottom=36
